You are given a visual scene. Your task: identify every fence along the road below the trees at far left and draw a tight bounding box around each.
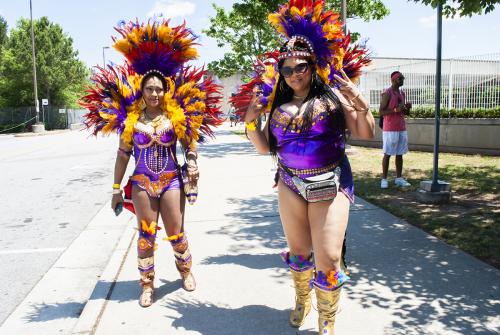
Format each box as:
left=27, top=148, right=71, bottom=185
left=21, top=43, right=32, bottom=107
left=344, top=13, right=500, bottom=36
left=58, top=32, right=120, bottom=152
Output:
left=0, top=106, right=87, bottom=134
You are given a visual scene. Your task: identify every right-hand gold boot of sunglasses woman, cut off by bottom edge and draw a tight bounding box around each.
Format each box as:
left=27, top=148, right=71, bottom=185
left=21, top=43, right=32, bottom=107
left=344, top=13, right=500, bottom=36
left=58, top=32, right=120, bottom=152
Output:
left=315, top=286, right=342, bottom=335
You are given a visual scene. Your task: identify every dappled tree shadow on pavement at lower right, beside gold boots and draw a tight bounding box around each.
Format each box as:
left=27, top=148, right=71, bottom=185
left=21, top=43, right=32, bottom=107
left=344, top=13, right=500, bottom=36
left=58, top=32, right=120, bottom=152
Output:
left=345, top=211, right=500, bottom=335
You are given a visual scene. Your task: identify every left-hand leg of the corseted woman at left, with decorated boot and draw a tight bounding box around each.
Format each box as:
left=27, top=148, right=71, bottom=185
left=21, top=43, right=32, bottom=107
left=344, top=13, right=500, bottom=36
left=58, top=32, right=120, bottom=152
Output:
left=132, top=186, right=159, bottom=307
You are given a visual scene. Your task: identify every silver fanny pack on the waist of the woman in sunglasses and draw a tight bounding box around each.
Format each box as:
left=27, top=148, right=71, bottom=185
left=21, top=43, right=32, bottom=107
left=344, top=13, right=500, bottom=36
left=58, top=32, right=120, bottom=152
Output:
left=280, top=164, right=341, bottom=202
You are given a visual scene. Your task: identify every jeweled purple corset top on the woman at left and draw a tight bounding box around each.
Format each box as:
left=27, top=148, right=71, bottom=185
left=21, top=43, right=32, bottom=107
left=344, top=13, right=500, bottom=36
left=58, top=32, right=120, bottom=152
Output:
left=133, top=114, right=176, bottom=180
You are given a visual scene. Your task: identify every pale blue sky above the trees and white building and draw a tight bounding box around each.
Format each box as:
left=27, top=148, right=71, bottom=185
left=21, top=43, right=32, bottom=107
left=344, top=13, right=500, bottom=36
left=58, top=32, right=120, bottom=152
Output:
left=0, top=0, right=500, bottom=70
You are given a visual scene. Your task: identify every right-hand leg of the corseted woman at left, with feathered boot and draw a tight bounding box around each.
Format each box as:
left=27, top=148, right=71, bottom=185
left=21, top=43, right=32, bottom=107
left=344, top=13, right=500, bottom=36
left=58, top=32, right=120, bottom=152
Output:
left=160, top=189, right=196, bottom=291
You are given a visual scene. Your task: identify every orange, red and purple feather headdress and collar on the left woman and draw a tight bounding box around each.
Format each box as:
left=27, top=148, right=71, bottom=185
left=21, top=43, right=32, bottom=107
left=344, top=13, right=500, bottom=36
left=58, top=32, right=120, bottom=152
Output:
left=80, top=20, right=221, bottom=147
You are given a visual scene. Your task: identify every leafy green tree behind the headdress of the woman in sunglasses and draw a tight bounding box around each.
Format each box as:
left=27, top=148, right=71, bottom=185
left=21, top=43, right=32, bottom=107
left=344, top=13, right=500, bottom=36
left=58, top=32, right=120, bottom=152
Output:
left=203, top=0, right=389, bottom=77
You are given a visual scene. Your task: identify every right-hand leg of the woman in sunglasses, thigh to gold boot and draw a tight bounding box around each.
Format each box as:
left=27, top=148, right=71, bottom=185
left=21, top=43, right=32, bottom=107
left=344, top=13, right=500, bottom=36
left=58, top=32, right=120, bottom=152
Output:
left=308, top=192, right=350, bottom=335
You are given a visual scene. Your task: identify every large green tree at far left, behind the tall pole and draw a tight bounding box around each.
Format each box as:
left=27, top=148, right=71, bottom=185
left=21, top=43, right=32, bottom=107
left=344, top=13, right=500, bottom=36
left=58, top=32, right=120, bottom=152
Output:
left=0, top=17, right=87, bottom=107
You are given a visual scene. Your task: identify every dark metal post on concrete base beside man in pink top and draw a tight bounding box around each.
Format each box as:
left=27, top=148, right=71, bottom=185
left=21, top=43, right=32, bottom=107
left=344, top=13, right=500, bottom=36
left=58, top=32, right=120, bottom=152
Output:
left=431, top=3, right=443, bottom=192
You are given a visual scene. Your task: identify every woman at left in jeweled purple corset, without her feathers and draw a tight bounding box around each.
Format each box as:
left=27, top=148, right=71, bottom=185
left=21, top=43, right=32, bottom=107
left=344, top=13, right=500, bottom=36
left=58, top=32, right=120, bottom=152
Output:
left=111, top=71, right=199, bottom=307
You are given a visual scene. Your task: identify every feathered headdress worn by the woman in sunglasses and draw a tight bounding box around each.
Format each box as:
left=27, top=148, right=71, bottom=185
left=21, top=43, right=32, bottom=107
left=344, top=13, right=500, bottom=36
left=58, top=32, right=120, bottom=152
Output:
left=231, top=0, right=370, bottom=119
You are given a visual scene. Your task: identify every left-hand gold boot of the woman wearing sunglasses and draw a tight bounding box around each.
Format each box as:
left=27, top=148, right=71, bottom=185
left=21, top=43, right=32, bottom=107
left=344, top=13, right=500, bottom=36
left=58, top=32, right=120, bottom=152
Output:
left=290, top=268, right=314, bottom=328
